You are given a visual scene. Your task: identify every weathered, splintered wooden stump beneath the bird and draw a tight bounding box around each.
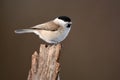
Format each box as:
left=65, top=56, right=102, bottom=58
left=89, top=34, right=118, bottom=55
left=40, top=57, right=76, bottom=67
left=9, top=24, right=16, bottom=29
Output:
left=28, top=44, right=61, bottom=80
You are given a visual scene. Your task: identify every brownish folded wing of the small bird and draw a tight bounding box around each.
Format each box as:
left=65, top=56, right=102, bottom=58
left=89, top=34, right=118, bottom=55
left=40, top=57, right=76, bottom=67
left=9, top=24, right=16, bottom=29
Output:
left=31, top=21, right=60, bottom=31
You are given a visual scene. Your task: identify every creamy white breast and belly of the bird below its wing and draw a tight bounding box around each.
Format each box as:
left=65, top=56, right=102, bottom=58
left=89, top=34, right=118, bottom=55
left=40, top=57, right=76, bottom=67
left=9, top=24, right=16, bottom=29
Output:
left=39, top=28, right=70, bottom=42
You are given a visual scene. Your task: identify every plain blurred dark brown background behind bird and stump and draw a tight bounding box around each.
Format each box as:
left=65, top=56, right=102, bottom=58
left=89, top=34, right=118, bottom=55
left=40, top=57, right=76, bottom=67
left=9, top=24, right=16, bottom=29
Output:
left=0, top=0, right=120, bottom=80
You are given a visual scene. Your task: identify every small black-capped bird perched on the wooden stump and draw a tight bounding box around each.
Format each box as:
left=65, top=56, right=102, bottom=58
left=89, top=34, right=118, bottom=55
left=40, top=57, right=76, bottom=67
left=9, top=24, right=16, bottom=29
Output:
left=15, top=16, right=72, bottom=44
